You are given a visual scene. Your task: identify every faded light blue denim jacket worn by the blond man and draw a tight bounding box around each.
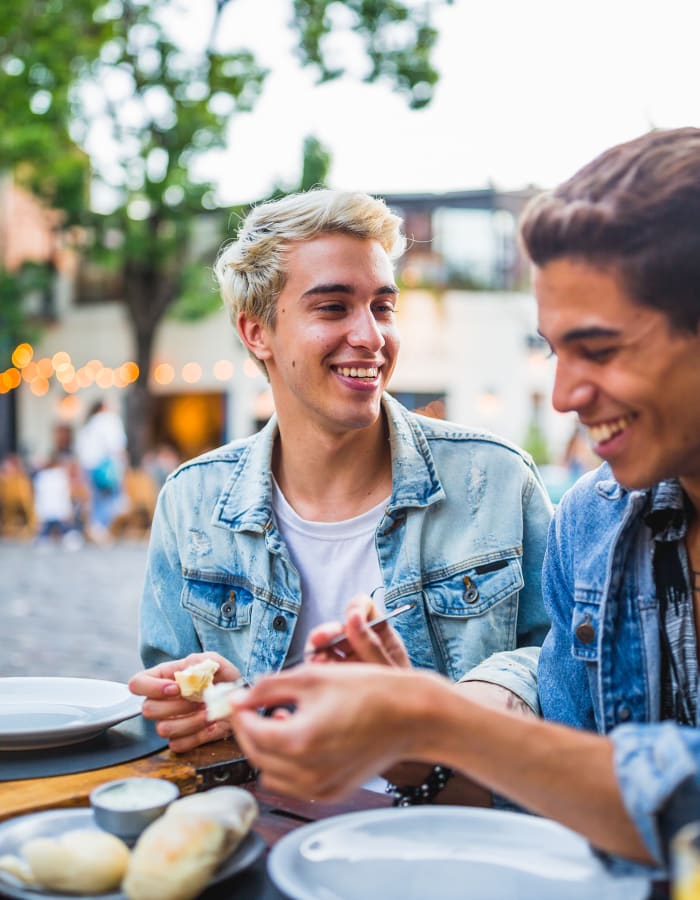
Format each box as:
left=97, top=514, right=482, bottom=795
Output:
left=141, top=395, right=551, bottom=707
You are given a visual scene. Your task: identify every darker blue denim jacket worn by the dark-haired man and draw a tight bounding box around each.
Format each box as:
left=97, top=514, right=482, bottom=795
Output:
left=538, top=464, right=700, bottom=868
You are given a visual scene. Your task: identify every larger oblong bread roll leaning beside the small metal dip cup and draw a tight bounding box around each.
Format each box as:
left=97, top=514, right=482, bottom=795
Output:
left=122, top=786, right=258, bottom=900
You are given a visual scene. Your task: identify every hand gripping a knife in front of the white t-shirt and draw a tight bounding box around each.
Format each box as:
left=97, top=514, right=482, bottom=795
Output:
left=306, top=594, right=411, bottom=669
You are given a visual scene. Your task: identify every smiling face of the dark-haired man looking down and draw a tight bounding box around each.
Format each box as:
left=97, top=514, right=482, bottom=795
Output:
left=535, top=259, right=700, bottom=496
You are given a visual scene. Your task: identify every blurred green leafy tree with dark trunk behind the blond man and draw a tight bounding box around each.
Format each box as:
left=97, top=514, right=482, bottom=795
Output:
left=0, top=0, right=452, bottom=463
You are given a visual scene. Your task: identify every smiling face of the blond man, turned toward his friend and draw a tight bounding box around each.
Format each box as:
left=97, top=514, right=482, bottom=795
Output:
left=239, top=233, right=399, bottom=435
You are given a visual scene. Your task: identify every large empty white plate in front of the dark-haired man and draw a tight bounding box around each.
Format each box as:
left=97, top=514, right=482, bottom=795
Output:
left=268, top=806, right=649, bottom=900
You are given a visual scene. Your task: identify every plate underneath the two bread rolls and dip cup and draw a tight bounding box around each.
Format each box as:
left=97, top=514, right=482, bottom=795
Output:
left=0, top=809, right=265, bottom=900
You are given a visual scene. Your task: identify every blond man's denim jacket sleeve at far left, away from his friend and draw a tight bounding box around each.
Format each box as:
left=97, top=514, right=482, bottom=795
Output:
left=140, top=482, right=202, bottom=668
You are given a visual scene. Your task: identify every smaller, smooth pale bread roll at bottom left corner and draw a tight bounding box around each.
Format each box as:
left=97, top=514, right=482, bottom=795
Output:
left=20, top=828, right=129, bottom=894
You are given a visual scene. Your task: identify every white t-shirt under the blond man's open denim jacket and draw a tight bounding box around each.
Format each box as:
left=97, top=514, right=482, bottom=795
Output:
left=272, top=479, right=389, bottom=660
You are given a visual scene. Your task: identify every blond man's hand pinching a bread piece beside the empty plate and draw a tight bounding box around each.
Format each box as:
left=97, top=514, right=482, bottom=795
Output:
left=129, top=653, right=240, bottom=753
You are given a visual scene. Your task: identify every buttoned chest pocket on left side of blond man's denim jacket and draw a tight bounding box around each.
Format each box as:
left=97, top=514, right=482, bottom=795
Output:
left=181, top=569, right=253, bottom=630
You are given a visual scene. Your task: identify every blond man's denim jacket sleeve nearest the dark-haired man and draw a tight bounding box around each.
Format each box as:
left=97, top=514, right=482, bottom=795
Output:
left=461, top=466, right=552, bottom=714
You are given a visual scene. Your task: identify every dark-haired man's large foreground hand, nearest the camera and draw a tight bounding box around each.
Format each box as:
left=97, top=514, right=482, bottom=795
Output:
left=231, top=665, right=434, bottom=800
